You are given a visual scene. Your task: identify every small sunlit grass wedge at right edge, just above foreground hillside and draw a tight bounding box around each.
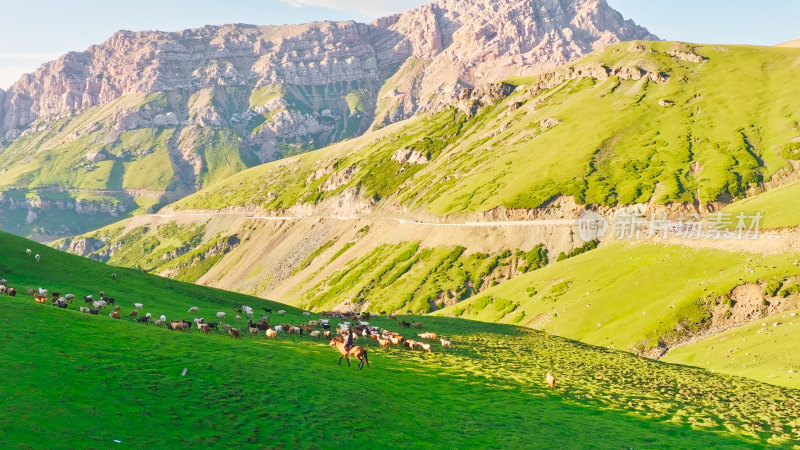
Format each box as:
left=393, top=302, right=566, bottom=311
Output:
left=663, top=312, right=800, bottom=388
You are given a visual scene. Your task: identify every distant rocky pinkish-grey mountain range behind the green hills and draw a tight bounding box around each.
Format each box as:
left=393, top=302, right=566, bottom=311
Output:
left=0, top=0, right=656, bottom=241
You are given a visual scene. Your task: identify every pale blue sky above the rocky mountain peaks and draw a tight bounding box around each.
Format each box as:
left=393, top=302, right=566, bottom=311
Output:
left=0, top=0, right=800, bottom=89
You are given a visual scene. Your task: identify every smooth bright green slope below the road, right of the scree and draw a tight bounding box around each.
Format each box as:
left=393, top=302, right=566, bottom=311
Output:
left=435, top=243, right=797, bottom=350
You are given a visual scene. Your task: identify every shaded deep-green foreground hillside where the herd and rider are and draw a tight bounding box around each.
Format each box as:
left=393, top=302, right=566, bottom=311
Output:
left=0, top=234, right=800, bottom=448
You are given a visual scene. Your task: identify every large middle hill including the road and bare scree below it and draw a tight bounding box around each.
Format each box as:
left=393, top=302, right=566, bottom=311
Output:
left=56, top=38, right=800, bottom=322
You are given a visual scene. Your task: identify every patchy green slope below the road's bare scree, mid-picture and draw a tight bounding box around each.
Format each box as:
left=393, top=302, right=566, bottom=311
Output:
left=289, top=242, right=547, bottom=314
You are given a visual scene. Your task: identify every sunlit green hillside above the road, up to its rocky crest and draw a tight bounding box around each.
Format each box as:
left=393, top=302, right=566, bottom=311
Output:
left=176, top=42, right=800, bottom=214
